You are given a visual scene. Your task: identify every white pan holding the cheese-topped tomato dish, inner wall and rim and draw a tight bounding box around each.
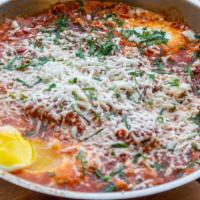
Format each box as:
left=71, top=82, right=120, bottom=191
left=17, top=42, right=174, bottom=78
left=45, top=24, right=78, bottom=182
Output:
left=0, top=0, right=200, bottom=200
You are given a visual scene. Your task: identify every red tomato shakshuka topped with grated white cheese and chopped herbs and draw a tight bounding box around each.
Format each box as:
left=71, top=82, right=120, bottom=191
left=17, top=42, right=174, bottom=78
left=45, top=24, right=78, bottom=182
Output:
left=0, top=1, right=200, bottom=192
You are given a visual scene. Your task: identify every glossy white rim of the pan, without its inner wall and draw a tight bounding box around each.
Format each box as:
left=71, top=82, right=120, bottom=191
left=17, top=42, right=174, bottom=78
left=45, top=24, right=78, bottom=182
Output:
left=0, top=0, right=200, bottom=200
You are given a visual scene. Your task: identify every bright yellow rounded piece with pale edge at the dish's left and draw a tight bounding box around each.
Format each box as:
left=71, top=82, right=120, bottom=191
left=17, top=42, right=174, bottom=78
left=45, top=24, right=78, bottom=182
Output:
left=0, top=126, right=35, bottom=171
